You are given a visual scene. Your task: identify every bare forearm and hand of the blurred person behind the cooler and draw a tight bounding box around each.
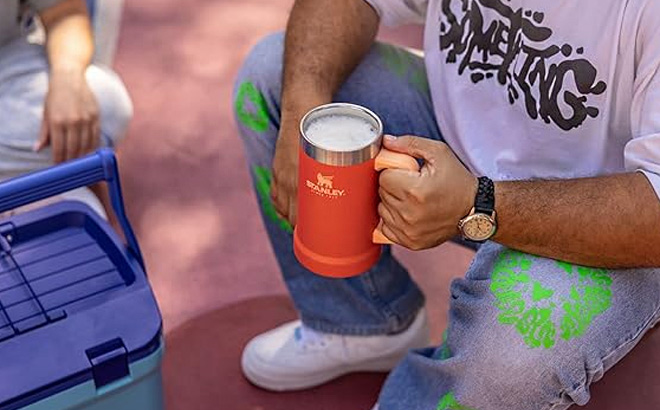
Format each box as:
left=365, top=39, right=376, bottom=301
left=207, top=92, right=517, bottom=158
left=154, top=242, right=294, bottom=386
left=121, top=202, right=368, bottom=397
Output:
left=34, top=0, right=100, bottom=162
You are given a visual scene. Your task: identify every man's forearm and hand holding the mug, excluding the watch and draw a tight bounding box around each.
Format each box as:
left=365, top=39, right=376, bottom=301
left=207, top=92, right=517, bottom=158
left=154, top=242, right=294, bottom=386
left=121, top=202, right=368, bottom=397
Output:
left=379, top=137, right=660, bottom=268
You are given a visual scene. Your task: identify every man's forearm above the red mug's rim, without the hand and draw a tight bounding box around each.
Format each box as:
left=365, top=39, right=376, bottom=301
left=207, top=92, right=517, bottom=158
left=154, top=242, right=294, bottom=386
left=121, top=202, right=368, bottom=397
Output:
left=282, top=0, right=378, bottom=120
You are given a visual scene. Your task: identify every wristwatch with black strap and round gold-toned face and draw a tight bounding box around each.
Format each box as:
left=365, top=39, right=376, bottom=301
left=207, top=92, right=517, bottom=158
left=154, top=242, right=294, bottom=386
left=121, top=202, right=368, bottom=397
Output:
left=458, top=177, right=497, bottom=242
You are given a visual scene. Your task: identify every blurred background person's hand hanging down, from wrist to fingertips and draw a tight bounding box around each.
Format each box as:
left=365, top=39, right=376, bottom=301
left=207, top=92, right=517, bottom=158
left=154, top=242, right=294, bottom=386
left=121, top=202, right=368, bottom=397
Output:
left=35, top=70, right=100, bottom=163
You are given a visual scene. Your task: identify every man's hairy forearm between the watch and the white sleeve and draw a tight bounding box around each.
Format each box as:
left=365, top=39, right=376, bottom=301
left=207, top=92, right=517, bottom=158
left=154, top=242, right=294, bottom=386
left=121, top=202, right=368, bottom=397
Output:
left=494, top=173, right=660, bottom=268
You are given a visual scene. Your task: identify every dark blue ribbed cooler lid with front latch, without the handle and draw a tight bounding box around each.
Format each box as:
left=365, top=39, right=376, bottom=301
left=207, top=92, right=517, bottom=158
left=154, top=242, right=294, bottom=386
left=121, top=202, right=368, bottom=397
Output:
left=0, top=201, right=161, bottom=409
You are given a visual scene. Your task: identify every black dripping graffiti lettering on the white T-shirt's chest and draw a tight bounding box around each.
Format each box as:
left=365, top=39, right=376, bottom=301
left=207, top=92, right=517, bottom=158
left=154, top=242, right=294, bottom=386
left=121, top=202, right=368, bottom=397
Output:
left=440, top=0, right=607, bottom=131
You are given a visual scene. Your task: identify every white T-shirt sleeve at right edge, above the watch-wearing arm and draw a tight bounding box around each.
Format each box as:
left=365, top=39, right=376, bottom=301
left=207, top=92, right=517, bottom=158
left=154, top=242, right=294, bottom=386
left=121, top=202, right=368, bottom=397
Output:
left=624, top=1, right=660, bottom=198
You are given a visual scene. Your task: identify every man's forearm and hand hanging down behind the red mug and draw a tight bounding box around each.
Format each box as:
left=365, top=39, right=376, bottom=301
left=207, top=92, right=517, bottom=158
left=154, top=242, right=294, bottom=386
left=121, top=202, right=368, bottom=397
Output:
left=272, top=0, right=379, bottom=224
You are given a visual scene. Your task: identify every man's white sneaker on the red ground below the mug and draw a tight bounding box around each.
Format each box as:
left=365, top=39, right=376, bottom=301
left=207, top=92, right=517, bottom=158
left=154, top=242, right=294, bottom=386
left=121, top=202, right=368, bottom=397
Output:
left=241, top=309, right=429, bottom=391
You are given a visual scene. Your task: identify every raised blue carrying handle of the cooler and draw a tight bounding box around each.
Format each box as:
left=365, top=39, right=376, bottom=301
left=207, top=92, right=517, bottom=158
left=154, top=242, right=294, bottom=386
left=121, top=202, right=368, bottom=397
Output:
left=0, top=148, right=146, bottom=272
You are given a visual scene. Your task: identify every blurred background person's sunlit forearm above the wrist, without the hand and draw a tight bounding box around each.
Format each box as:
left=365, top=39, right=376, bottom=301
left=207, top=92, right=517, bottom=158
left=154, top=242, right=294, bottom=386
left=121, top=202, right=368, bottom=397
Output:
left=40, top=0, right=94, bottom=74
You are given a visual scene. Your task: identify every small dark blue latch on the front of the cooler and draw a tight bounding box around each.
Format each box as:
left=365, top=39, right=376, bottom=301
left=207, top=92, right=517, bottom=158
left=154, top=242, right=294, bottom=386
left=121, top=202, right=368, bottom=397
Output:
left=85, top=338, right=130, bottom=389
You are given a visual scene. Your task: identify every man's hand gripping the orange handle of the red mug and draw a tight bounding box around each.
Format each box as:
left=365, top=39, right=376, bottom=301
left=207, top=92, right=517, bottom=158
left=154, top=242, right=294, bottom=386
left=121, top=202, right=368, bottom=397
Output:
left=378, top=136, right=477, bottom=250
